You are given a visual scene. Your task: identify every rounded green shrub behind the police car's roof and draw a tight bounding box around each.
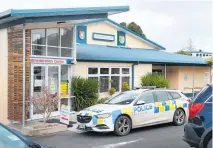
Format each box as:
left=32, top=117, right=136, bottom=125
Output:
left=141, top=73, right=169, bottom=88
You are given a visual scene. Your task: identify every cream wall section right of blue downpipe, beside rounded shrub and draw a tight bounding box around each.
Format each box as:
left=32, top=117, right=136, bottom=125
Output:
left=134, top=64, right=152, bottom=87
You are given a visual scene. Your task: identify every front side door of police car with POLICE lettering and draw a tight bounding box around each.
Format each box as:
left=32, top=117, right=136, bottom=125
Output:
left=133, top=91, right=155, bottom=127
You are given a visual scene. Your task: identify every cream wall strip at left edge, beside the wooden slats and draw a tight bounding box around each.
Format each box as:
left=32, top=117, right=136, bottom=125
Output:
left=0, top=29, right=8, bottom=124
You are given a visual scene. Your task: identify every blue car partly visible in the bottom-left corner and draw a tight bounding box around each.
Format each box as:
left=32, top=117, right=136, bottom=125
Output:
left=0, top=123, right=48, bottom=148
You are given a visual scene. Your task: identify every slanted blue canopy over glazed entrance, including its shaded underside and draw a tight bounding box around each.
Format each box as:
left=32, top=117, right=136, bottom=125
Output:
left=0, top=6, right=129, bottom=29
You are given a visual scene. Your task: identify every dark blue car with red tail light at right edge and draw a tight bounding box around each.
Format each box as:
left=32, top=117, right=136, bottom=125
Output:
left=183, top=84, right=212, bottom=148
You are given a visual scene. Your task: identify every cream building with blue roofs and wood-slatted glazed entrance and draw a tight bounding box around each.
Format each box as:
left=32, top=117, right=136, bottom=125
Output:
left=0, top=6, right=209, bottom=124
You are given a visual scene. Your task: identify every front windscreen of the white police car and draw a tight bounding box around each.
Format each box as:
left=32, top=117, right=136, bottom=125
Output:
left=106, top=92, right=140, bottom=105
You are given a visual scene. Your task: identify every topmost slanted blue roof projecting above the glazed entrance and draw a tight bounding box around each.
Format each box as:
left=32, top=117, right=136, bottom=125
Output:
left=0, top=6, right=129, bottom=26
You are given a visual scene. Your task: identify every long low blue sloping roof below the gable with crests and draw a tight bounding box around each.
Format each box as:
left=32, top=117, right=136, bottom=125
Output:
left=77, top=44, right=207, bottom=65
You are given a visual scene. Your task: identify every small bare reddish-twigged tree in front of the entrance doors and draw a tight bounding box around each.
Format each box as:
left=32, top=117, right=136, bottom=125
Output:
left=31, top=86, right=59, bottom=124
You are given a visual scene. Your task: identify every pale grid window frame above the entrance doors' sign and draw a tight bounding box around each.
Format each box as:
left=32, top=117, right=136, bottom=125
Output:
left=30, top=26, right=75, bottom=59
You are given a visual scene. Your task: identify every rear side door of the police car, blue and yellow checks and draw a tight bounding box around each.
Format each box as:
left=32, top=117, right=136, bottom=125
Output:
left=154, top=91, right=175, bottom=122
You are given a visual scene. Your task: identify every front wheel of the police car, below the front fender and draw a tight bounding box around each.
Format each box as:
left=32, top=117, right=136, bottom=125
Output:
left=114, top=116, right=132, bottom=136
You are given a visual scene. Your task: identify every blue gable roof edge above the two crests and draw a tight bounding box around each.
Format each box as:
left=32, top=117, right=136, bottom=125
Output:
left=78, top=18, right=166, bottom=50
